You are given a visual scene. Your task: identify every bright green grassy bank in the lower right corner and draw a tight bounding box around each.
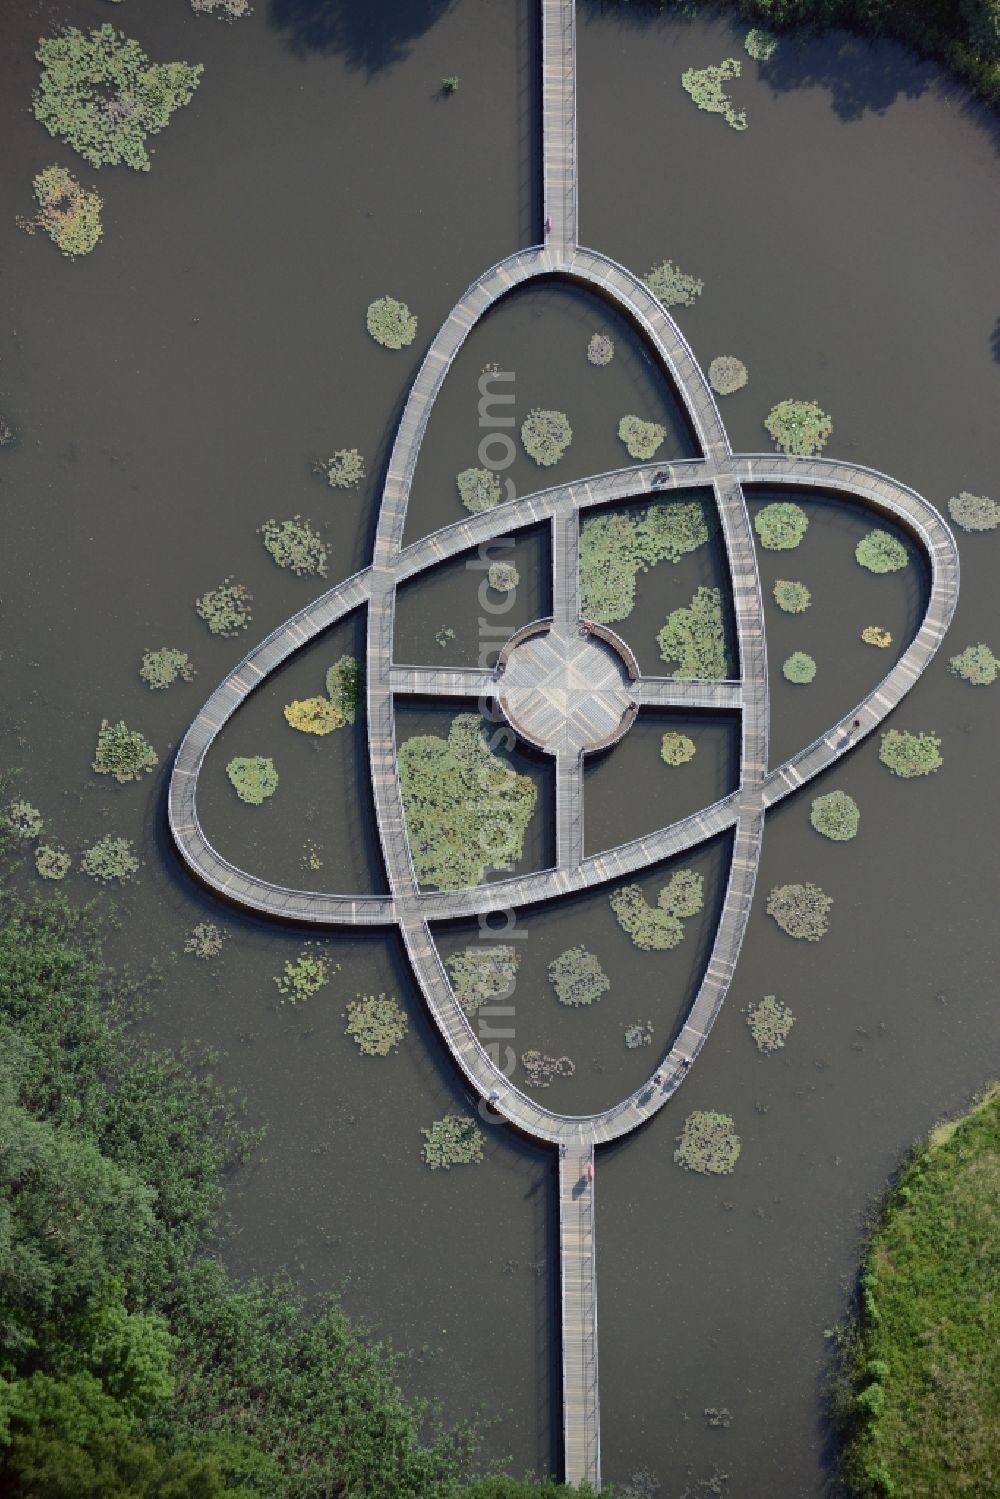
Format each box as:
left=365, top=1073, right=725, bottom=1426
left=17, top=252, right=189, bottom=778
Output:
left=837, top=1084, right=1000, bottom=1499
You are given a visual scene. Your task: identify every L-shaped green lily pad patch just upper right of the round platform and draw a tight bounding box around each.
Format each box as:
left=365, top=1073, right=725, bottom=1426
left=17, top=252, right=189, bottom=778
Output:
left=580, top=499, right=709, bottom=625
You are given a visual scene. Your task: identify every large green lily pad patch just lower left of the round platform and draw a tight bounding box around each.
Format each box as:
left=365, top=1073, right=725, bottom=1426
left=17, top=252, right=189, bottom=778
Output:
left=399, top=714, right=538, bottom=890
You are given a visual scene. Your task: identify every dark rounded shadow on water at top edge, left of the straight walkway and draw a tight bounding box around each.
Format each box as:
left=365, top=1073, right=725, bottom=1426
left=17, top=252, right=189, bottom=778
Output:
left=267, top=0, right=453, bottom=73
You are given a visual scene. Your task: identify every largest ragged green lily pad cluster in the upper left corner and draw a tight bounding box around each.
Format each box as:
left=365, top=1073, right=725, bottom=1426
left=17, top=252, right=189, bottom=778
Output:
left=33, top=25, right=204, bottom=172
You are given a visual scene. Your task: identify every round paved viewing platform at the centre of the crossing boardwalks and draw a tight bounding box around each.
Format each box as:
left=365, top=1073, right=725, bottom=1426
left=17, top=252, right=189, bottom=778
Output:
left=496, top=619, right=639, bottom=755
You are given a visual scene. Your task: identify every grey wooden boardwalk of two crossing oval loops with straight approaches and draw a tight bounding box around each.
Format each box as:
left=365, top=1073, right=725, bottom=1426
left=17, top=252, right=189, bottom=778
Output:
left=168, top=0, right=958, bottom=1487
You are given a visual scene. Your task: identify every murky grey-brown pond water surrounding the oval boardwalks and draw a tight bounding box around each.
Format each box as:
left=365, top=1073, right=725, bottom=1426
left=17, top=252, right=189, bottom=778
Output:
left=0, top=0, right=1000, bottom=1496
